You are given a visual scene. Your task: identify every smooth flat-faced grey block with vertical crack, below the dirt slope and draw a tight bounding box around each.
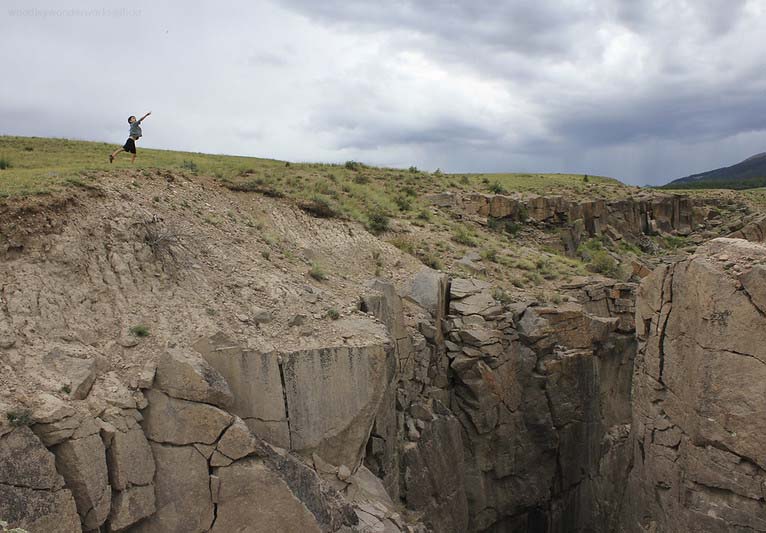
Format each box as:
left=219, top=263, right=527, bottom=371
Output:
left=195, top=319, right=395, bottom=467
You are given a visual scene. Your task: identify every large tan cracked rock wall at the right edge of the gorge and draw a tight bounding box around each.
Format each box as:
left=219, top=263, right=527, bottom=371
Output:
left=623, top=239, right=766, bottom=532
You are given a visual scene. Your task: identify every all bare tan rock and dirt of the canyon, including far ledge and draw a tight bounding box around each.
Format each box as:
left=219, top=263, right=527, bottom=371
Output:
left=0, top=184, right=766, bottom=533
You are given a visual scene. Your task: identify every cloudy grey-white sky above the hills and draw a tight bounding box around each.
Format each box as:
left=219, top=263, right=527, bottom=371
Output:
left=0, top=0, right=766, bottom=184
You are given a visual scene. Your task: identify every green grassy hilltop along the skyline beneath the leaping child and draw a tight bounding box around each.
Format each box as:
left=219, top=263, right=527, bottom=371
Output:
left=0, top=137, right=620, bottom=205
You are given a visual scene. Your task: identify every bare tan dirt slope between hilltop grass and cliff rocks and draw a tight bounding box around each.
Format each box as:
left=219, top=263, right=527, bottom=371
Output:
left=0, top=172, right=419, bottom=404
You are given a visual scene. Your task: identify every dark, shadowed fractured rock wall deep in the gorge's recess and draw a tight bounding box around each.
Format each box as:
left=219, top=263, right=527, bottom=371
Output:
left=368, top=273, right=635, bottom=531
